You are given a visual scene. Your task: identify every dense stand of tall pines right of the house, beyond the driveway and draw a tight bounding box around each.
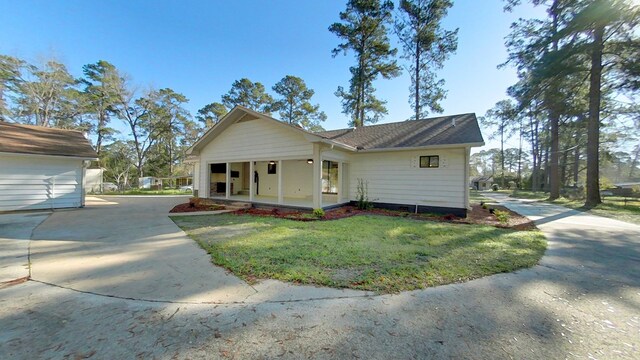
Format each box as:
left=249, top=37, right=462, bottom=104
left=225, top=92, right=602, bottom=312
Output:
left=483, top=0, right=640, bottom=207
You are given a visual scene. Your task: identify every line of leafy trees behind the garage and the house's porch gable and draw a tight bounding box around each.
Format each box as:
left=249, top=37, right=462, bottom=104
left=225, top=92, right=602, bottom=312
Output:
left=0, top=55, right=326, bottom=187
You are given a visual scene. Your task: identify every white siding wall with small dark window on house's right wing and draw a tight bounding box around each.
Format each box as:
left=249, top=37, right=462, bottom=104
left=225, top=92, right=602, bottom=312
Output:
left=349, top=148, right=467, bottom=209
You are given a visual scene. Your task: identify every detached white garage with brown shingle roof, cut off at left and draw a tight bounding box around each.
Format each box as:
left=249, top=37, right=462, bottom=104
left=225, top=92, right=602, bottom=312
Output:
left=0, top=121, right=97, bottom=211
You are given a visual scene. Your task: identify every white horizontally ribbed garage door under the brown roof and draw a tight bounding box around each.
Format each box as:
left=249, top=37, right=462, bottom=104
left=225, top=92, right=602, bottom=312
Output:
left=0, top=155, right=83, bottom=211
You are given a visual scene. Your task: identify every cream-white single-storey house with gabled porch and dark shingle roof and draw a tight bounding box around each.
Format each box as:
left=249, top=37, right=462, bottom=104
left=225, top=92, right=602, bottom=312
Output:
left=187, top=106, right=484, bottom=215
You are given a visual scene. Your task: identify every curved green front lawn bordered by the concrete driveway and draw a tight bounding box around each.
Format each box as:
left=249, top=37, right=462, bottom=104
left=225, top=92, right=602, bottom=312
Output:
left=172, top=214, right=546, bottom=293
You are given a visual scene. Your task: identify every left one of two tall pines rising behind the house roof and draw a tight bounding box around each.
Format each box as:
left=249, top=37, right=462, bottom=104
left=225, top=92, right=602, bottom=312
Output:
left=329, top=0, right=400, bottom=127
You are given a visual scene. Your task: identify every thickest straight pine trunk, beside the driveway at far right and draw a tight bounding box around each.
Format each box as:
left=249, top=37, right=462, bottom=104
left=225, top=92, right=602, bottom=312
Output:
left=584, top=25, right=604, bottom=208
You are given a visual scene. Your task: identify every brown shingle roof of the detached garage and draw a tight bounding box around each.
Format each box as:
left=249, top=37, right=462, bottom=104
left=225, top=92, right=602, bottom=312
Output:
left=0, top=121, right=98, bottom=159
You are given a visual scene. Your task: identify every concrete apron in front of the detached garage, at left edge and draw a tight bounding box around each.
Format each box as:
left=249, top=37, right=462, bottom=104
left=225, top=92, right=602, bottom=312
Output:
left=0, top=212, right=50, bottom=286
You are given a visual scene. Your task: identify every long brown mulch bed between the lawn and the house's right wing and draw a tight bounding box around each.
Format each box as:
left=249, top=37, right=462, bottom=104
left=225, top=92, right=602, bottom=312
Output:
left=231, top=204, right=536, bottom=230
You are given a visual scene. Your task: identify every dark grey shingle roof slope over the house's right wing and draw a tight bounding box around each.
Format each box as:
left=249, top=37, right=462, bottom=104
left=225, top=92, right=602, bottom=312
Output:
left=317, top=114, right=484, bottom=150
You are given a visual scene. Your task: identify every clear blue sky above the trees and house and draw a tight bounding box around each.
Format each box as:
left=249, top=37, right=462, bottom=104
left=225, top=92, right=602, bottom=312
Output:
left=0, top=0, right=540, bottom=146
